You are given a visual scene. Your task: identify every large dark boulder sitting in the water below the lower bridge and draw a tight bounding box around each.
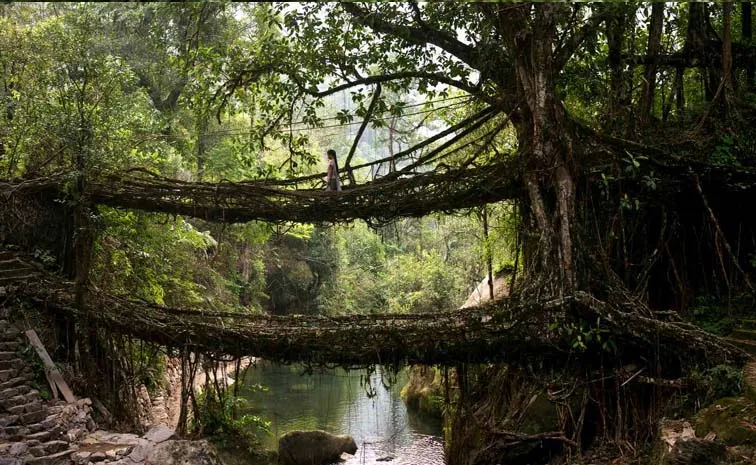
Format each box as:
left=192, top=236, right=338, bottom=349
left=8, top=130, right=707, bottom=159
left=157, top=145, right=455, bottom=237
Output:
left=278, top=431, right=357, bottom=465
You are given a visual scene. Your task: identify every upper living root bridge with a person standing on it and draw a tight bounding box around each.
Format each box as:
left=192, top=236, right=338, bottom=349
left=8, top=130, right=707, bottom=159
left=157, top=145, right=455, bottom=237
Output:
left=88, top=164, right=517, bottom=223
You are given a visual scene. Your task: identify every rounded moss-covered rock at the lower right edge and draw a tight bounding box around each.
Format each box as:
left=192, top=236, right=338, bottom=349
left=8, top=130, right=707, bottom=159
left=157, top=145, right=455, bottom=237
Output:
left=696, top=397, right=756, bottom=446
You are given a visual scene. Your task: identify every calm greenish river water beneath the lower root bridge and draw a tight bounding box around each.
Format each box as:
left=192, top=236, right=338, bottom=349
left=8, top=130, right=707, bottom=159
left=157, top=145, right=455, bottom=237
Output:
left=241, top=361, right=444, bottom=465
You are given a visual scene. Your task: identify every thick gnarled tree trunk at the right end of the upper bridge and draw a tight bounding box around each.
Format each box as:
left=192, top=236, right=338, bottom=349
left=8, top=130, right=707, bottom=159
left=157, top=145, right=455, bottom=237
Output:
left=514, top=4, right=576, bottom=291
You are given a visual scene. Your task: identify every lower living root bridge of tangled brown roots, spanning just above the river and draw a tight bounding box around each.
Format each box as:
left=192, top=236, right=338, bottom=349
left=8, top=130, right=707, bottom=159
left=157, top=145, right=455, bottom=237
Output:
left=26, top=287, right=747, bottom=367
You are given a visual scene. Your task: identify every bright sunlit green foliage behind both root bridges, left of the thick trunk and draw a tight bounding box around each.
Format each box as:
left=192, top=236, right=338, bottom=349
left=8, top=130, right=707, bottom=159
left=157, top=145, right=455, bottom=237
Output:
left=0, top=3, right=514, bottom=320
